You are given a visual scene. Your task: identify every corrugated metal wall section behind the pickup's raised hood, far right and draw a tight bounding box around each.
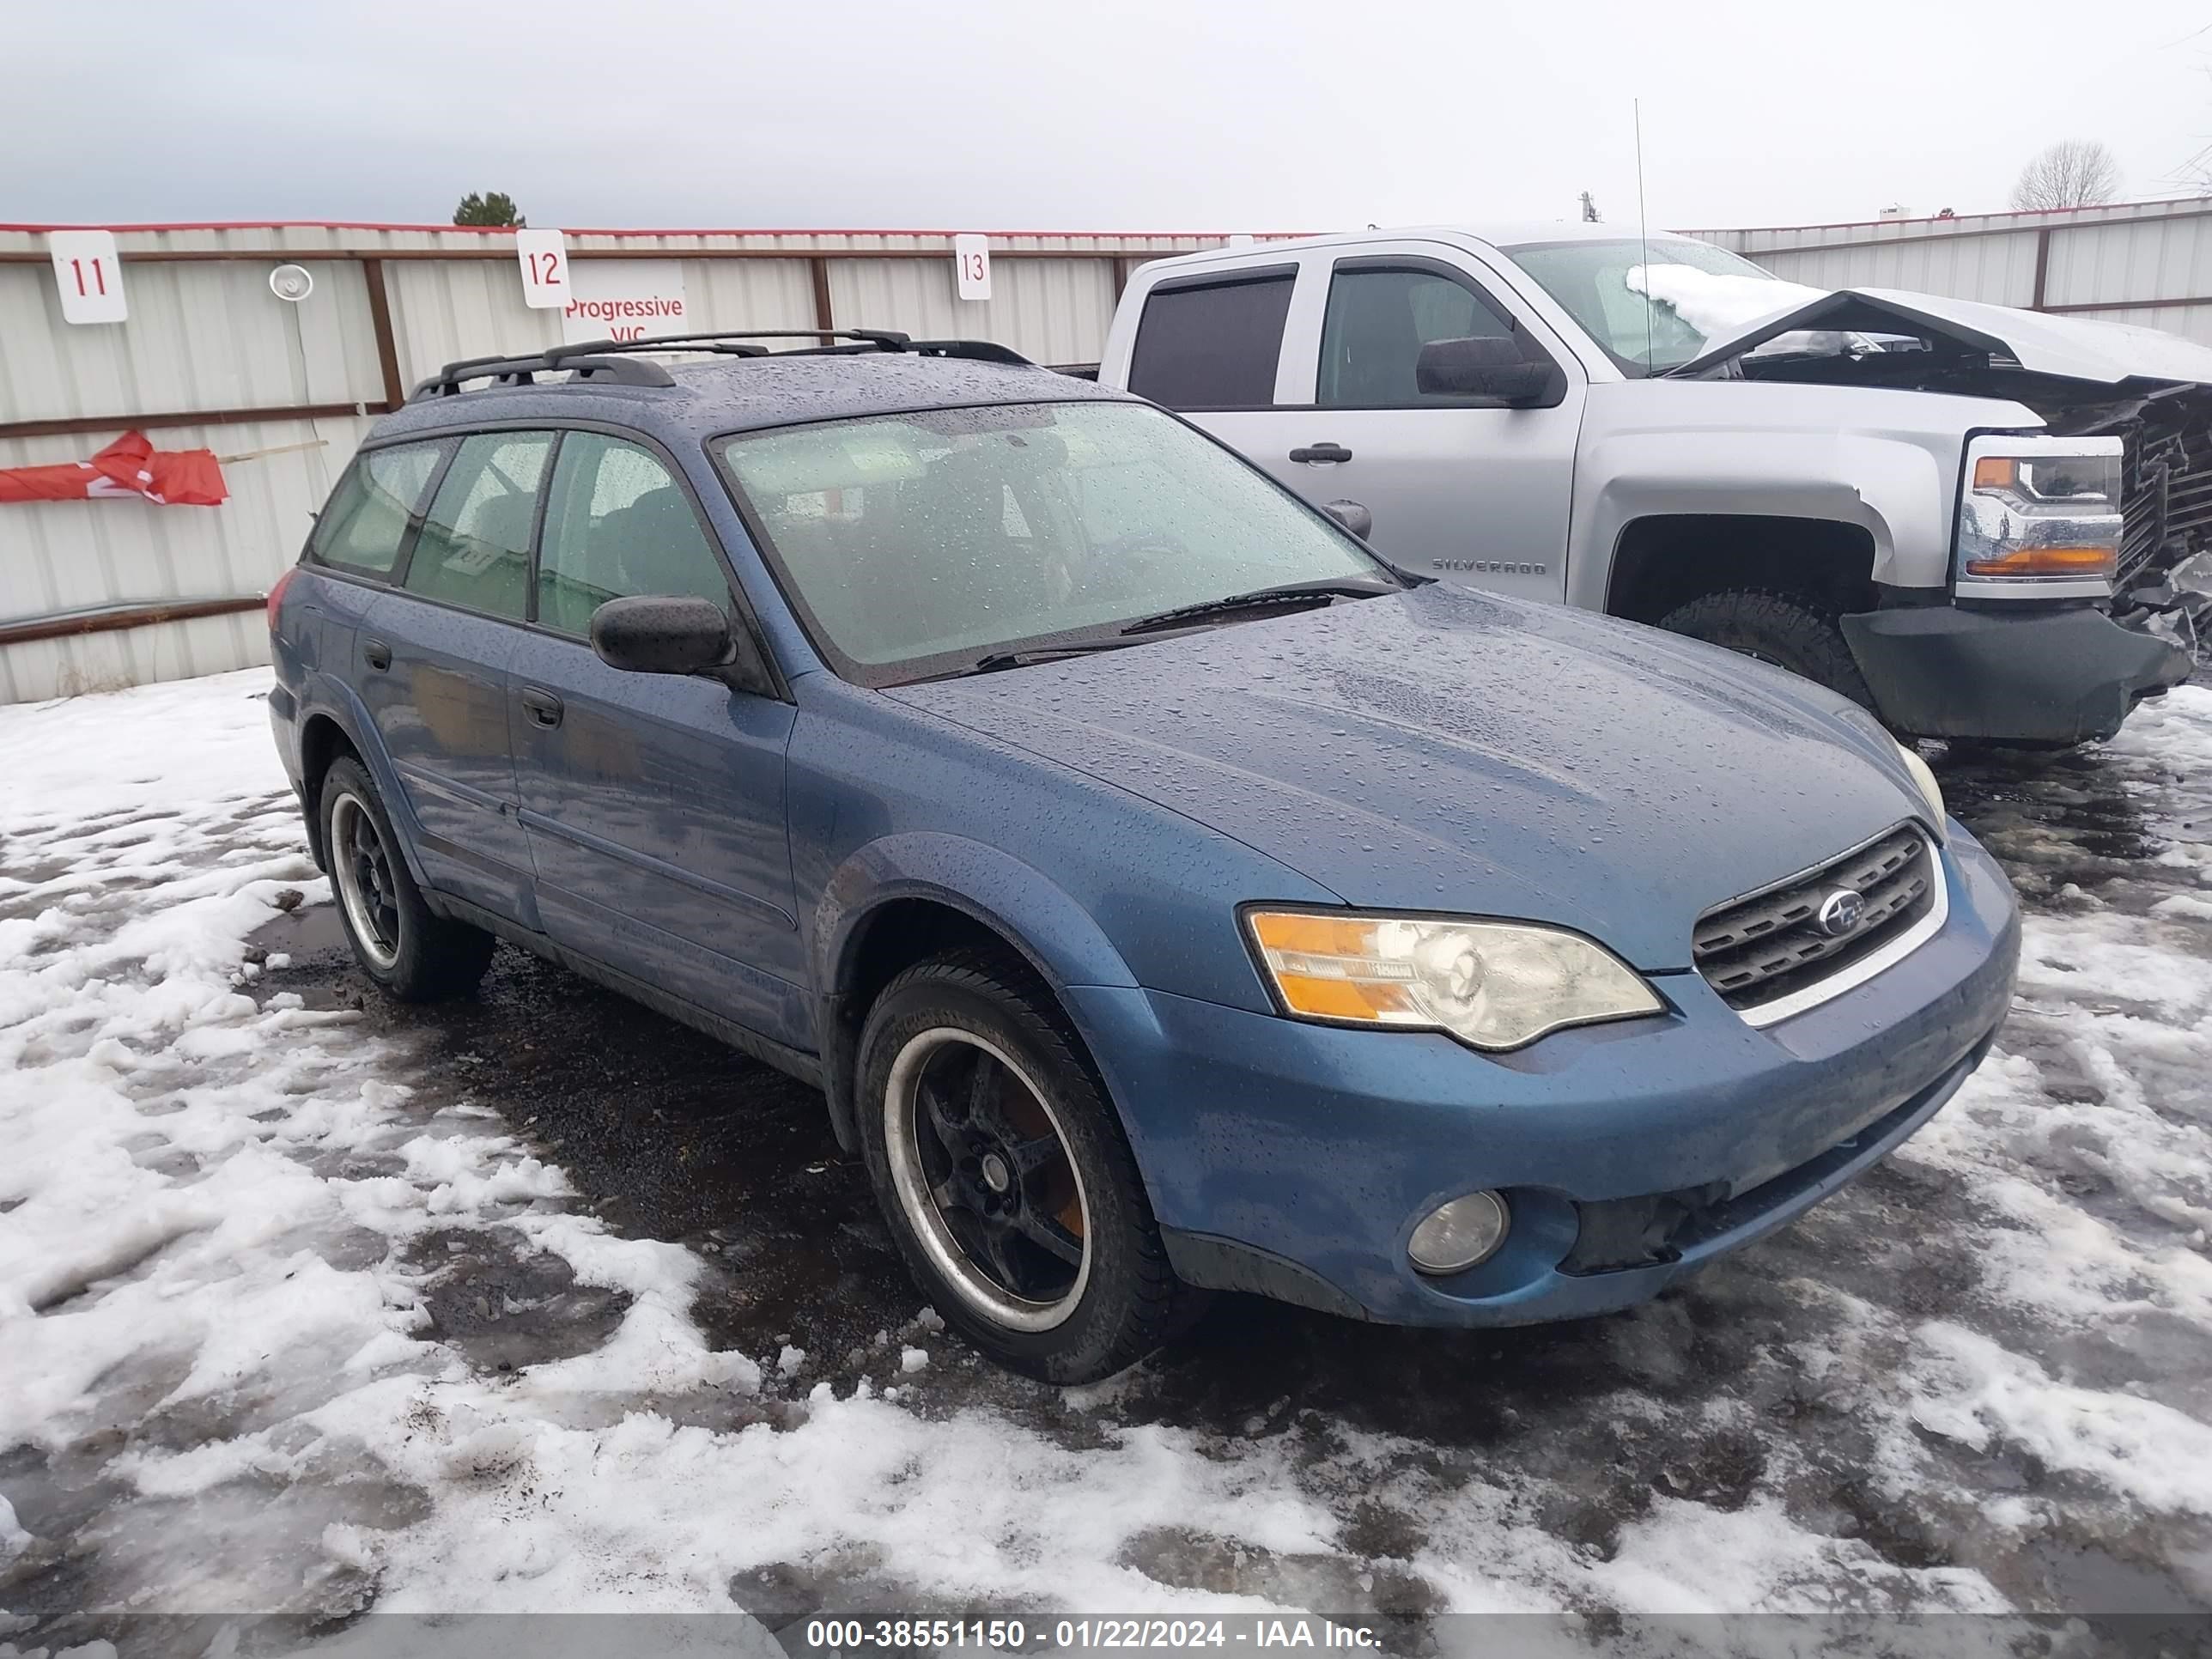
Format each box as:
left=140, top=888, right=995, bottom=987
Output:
left=1683, top=197, right=2212, bottom=345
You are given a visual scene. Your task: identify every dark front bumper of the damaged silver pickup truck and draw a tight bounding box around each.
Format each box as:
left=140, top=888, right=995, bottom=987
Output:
left=1843, top=604, right=2190, bottom=744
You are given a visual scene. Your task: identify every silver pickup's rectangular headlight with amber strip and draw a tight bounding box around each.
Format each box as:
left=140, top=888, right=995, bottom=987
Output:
left=1958, top=435, right=2121, bottom=599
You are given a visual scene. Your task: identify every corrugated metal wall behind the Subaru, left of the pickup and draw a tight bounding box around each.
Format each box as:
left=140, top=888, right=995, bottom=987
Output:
left=0, top=226, right=1224, bottom=702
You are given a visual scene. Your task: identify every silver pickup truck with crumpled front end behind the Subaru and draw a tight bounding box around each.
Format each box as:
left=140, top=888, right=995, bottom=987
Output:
left=1097, top=226, right=2212, bottom=745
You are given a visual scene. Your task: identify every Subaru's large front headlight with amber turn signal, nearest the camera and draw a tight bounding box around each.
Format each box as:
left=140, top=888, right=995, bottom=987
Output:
left=1245, top=909, right=1663, bottom=1048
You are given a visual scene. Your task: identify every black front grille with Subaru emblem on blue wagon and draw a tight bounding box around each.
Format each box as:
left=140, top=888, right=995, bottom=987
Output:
left=1690, top=827, right=1936, bottom=1011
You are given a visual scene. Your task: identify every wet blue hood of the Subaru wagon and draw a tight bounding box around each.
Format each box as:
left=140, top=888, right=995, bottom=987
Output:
left=887, top=584, right=1924, bottom=971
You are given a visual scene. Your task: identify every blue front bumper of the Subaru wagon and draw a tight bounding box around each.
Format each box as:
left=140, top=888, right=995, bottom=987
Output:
left=1068, top=827, right=2020, bottom=1325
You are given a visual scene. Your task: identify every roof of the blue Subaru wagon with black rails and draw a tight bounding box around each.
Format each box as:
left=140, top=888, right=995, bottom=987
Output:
left=372, top=352, right=1141, bottom=442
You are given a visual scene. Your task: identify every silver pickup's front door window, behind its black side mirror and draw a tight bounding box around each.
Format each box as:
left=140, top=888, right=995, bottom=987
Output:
left=1314, top=268, right=1513, bottom=410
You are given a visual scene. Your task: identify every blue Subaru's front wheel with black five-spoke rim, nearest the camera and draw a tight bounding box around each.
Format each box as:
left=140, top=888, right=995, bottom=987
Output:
left=858, top=951, right=1197, bottom=1382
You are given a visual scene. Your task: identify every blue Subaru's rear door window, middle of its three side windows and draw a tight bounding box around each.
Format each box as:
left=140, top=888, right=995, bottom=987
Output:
left=404, top=431, right=553, bottom=622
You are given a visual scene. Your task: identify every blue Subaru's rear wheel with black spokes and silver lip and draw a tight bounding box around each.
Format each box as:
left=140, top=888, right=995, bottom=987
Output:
left=316, top=759, right=493, bottom=1002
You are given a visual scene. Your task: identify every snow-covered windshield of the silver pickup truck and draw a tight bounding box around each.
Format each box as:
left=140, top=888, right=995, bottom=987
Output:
left=1504, top=237, right=1820, bottom=374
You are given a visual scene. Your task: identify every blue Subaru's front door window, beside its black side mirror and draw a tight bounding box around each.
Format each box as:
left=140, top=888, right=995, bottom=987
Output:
left=538, top=431, right=730, bottom=639
